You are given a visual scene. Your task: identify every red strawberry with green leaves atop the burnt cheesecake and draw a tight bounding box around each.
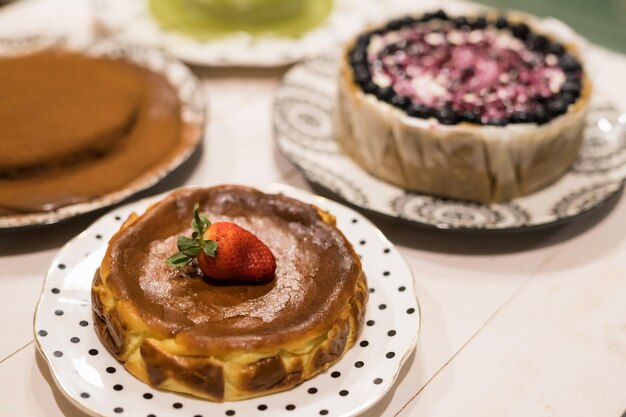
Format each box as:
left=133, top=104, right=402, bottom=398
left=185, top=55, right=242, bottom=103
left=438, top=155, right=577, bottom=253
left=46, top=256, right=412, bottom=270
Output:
left=166, top=203, right=276, bottom=282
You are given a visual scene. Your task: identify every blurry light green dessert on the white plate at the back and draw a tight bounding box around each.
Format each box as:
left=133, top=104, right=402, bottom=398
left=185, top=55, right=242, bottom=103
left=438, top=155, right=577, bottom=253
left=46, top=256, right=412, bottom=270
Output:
left=149, top=0, right=333, bottom=39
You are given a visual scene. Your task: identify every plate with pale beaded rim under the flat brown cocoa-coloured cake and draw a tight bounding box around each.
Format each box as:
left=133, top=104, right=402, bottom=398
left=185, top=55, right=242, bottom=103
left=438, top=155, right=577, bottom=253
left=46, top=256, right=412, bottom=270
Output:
left=0, top=37, right=206, bottom=229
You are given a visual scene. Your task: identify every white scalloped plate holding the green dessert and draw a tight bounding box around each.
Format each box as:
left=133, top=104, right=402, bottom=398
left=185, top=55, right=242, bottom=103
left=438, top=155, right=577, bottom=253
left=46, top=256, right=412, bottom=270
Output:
left=93, top=0, right=379, bottom=67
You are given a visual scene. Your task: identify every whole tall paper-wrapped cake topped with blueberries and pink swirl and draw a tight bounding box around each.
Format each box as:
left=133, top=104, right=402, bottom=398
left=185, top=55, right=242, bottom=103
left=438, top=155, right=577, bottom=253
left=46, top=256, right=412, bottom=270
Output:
left=336, top=11, right=591, bottom=203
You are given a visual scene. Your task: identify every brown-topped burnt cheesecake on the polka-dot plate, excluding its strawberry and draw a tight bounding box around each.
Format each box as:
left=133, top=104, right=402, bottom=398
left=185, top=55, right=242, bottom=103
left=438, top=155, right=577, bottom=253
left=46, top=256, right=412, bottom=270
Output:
left=92, top=186, right=368, bottom=401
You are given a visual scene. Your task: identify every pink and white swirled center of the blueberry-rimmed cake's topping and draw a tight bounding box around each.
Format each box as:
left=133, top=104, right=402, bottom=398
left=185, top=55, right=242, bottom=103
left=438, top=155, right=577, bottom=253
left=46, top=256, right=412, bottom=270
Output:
left=367, top=21, right=566, bottom=123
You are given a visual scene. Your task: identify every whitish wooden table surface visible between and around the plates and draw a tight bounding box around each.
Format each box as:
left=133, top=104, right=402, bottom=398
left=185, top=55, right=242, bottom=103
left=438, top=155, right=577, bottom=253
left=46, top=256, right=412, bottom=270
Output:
left=0, top=0, right=626, bottom=417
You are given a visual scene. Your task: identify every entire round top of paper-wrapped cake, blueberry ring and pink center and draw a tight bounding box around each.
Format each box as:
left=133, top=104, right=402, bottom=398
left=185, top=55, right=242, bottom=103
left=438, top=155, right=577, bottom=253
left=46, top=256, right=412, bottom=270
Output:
left=350, top=11, right=582, bottom=125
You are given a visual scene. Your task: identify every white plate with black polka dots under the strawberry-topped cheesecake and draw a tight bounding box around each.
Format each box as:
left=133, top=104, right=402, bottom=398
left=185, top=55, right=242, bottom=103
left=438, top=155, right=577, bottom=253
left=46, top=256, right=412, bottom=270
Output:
left=34, top=185, right=420, bottom=417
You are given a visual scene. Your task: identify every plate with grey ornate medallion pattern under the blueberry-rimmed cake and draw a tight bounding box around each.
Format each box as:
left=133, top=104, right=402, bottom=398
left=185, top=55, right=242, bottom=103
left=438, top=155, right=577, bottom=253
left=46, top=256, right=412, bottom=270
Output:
left=273, top=56, right=626, bottom=231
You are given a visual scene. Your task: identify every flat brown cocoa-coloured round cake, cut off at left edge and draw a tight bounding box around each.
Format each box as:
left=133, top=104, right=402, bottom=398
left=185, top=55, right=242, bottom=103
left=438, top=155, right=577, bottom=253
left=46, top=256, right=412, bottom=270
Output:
left=0, top=51, right=189, bottom=215
